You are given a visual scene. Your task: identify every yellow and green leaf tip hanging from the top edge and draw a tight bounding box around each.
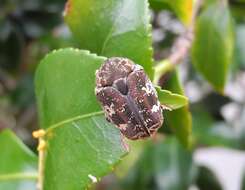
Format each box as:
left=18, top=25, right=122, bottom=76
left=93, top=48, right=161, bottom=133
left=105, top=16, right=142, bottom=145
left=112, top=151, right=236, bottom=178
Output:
left=150, top=0, right=193, bottom=25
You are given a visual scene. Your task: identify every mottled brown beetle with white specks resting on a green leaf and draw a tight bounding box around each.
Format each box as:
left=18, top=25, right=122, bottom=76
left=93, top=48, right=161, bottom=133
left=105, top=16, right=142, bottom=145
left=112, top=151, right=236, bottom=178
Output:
left=95, top=57, right=163, bottom=140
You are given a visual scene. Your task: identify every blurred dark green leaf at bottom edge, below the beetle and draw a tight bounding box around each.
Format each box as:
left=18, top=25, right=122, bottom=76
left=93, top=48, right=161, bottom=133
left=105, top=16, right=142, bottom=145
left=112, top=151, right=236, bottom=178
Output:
left=123, top=137, right=195, bottom=190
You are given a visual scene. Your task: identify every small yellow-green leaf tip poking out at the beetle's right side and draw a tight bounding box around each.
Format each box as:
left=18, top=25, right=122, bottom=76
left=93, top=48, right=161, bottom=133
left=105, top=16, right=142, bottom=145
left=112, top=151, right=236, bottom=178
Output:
left=155, top=86, right=188, bottom=110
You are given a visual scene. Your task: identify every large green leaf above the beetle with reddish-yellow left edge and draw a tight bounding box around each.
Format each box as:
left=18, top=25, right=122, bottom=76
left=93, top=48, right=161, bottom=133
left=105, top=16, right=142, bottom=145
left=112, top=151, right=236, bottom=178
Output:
left=65, top=0, right=152, bottom=77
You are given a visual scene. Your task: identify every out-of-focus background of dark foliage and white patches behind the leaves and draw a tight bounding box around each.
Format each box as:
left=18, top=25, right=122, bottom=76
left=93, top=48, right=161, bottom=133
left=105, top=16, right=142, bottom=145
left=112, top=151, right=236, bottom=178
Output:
left=0, top=0, right=245, bottom=190
